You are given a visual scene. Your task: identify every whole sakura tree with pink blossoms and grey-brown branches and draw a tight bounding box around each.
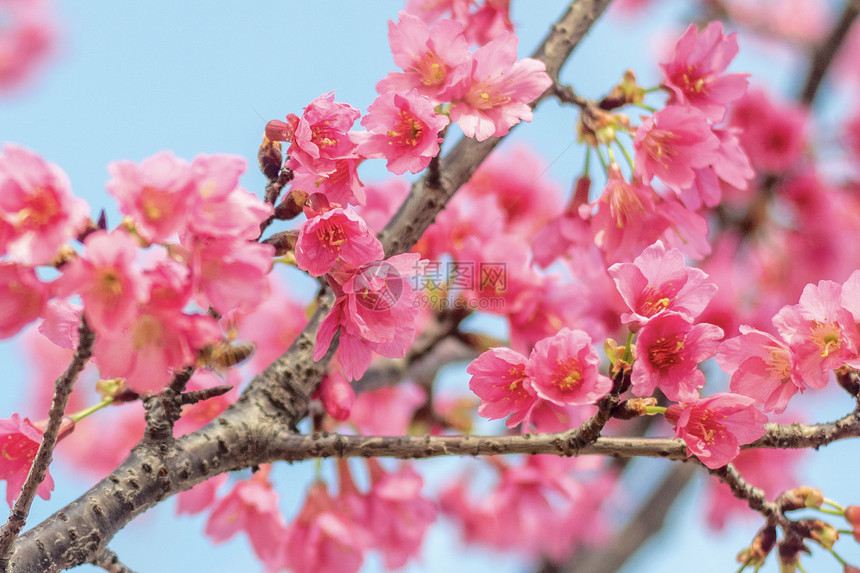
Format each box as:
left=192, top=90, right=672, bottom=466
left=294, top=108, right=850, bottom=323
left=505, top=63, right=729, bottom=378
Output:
left=0, top=0, right=860, bottom=572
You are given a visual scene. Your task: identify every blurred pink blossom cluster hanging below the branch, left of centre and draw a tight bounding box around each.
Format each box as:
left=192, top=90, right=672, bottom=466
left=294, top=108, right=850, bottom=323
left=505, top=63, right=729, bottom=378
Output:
left=178, top=459, right=436, bottom=573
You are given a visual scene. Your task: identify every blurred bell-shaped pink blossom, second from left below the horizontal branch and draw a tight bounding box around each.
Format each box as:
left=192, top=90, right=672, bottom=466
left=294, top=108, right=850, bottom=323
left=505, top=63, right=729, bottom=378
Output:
left=204, top=470, right=287, bottom=571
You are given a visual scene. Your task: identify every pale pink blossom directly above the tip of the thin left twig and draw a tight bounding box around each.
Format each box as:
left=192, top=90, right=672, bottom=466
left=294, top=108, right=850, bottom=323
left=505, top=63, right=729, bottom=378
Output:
left=57, top=230, right=147, bottom=333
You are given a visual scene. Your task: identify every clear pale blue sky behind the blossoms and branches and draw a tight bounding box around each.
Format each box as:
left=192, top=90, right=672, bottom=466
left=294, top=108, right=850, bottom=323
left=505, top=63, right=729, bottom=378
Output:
left=0, top=0, right=860, bottom=573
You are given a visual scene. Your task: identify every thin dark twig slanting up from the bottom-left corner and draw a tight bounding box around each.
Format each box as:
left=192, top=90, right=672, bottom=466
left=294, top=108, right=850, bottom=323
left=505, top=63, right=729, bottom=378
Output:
left=0, top=315, right=95, bottom=571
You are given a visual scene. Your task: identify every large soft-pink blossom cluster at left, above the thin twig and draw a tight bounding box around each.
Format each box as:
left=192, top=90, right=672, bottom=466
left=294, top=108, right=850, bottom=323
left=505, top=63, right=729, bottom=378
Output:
left=0, top=145, right=273, bottom=394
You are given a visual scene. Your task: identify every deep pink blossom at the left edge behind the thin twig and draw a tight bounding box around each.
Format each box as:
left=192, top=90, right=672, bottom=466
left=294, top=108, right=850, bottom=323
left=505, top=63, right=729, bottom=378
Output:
left=0, top=414, right=75, bottom=507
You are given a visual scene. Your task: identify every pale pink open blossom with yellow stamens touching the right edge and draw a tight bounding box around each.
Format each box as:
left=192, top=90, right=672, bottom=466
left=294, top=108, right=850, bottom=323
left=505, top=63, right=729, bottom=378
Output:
left=773, top=281, right=860, bottom=388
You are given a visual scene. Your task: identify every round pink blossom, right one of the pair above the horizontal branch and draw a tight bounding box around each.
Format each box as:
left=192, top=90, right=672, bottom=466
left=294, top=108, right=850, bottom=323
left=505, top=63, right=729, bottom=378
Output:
left=525, top=327, right=612, bottom=406
